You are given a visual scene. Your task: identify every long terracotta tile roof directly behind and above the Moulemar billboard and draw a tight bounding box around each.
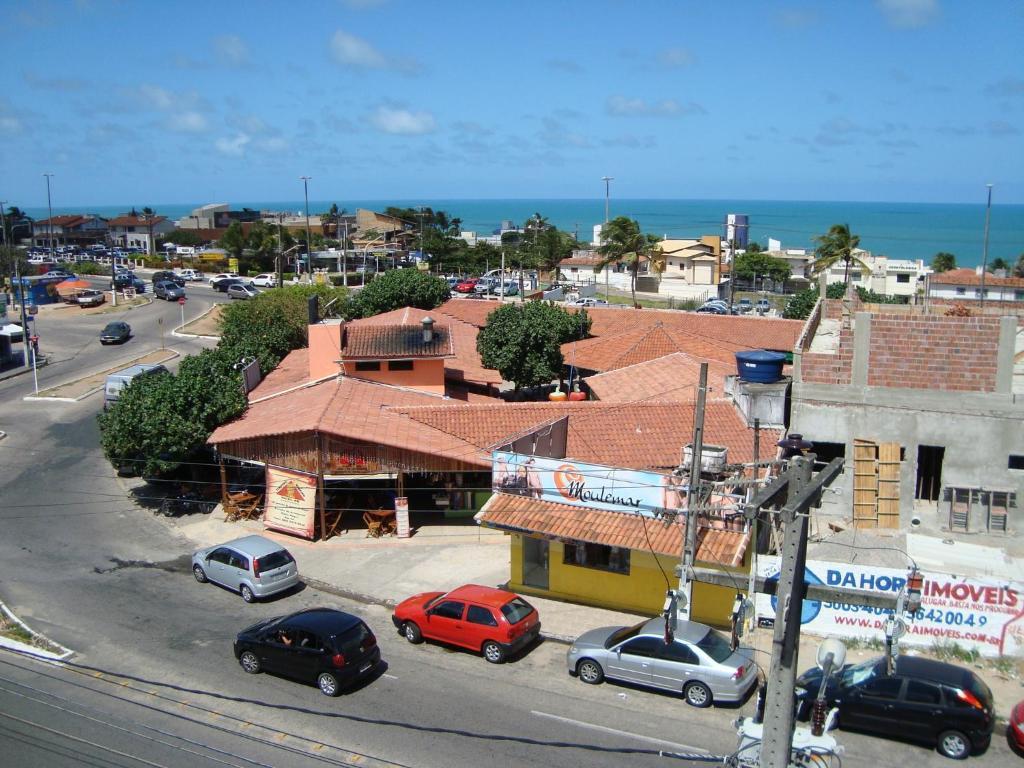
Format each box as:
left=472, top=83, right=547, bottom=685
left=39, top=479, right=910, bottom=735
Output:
left=395, top=399, right=779, bottom=469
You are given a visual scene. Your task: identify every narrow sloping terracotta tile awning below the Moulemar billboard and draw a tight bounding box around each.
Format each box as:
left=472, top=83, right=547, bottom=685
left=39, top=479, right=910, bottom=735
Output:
left=476, top=494, right=750, bottom=567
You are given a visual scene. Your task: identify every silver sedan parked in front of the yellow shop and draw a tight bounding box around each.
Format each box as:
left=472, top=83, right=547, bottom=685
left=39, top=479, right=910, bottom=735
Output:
left=565, top=618, right=758, bottom=707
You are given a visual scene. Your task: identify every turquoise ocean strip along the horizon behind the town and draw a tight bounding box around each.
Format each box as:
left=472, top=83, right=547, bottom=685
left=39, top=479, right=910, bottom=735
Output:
left=18, top=198, right=1024, bottom=266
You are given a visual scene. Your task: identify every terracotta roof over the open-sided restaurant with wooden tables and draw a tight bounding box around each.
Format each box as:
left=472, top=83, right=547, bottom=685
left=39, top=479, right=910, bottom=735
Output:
left=208, top=377, right=490, bottom=467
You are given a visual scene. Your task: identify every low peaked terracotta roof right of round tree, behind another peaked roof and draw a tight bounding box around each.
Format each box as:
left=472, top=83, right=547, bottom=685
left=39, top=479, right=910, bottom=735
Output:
left=562, top=323, right=754, bottom=371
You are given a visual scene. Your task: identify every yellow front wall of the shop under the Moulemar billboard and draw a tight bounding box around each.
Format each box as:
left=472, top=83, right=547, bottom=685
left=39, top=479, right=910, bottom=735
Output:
left=509, top=534, right=746, bottom=627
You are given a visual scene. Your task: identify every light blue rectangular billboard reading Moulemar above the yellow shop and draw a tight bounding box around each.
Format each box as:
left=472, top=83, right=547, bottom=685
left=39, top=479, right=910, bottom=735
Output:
left=490, top=451, right=686, bottom=517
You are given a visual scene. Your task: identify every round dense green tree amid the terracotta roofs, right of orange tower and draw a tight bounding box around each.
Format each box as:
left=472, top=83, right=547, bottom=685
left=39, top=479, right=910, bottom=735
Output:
left=476, top=301, right=590, bottom=390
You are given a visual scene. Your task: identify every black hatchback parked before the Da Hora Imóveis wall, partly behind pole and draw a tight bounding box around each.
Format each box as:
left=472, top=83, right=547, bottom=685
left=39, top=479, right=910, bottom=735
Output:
left=797, top=656, right=995, bottom=760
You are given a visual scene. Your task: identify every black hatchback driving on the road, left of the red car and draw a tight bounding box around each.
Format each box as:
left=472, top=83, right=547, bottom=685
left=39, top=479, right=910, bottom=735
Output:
left=234, top=608, right=381, bottom=696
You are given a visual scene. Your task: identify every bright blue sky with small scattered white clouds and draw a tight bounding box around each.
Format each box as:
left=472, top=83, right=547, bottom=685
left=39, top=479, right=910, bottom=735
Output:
left=0, top=0, right=1024, bottom=207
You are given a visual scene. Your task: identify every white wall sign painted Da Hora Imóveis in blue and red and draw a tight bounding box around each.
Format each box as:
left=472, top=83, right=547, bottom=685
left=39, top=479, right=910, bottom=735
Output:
left=755, top=556, right=1024, bottom=656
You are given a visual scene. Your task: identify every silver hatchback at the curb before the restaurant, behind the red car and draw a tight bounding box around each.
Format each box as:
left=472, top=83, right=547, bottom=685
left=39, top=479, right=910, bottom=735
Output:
left=193, top=536, right=299, bottom=603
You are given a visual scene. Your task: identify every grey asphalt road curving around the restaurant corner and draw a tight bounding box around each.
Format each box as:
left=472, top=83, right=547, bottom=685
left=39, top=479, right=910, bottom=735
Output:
left=0, top=296, right=1018, bottom=768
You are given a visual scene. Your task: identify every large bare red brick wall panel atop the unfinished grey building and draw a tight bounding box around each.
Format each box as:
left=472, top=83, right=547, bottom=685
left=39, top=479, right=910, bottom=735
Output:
left=864, top=314, right=999, bottom=392
